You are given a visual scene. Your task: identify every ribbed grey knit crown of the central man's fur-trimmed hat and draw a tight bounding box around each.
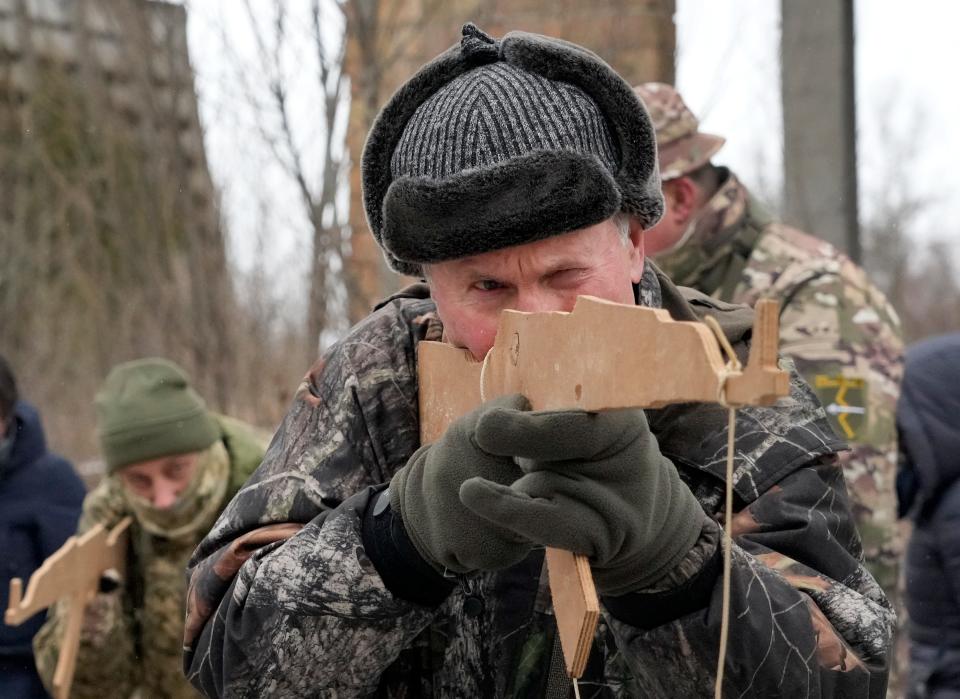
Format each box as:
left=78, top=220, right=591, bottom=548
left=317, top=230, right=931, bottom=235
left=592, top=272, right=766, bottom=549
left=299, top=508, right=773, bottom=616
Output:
left=390, top=61, right=619, bottom=180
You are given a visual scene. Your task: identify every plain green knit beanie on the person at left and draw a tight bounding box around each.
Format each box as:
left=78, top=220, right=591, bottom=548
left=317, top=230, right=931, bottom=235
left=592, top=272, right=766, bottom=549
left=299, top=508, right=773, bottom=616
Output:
left=95, top=357, right=220, bottom=473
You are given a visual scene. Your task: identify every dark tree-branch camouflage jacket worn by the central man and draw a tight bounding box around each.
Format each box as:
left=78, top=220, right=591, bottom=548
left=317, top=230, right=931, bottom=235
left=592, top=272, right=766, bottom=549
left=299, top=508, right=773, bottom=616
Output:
left=184, top=266, right=891, bottom=697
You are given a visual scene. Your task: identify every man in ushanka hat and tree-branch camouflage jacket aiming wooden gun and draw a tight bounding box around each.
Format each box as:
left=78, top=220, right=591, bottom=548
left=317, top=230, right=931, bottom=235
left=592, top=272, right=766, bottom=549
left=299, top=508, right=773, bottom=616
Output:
left=185, top=25, right=891, bottom=697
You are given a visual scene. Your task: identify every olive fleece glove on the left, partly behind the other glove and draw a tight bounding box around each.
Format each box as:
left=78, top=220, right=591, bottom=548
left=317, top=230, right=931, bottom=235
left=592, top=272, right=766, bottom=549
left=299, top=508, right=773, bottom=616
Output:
left=390, top=395, right=533, bottom=573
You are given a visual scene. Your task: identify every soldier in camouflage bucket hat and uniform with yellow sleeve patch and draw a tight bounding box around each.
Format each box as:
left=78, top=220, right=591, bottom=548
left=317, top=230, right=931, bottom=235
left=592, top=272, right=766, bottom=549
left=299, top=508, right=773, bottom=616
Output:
left=636, top=78, right=903, bottom=680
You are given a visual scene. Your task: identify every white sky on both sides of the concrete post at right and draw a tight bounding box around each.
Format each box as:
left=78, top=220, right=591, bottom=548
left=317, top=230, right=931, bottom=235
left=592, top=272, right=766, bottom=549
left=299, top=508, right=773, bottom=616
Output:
left=676, top=0, right=960, bottom=241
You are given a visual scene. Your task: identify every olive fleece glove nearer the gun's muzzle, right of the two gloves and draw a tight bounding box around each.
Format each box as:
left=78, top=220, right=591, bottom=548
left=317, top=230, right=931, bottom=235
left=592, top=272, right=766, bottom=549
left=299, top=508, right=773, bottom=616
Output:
left=460, top=410, right=703, bottom=595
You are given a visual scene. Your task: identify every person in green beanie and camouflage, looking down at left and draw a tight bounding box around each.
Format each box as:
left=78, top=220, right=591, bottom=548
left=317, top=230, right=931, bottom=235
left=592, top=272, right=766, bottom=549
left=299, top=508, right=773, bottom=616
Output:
left=34, top=358, right=267, bottom=699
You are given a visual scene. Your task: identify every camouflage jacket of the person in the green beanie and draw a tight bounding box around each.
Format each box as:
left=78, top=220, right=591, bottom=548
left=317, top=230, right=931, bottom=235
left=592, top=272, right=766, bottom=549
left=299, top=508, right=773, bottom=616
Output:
left=34, top=415, right=267, bottom=699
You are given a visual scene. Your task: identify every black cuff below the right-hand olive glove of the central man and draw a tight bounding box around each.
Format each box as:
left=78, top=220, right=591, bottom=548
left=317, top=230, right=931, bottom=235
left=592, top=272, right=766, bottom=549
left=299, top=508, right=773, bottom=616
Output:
left=603, top=545, right=723, bottom=631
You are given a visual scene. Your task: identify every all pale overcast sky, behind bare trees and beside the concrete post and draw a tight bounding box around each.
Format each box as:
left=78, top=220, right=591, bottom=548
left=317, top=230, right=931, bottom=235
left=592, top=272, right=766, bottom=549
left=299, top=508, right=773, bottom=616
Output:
left=188, top=0, right=960, bottom=284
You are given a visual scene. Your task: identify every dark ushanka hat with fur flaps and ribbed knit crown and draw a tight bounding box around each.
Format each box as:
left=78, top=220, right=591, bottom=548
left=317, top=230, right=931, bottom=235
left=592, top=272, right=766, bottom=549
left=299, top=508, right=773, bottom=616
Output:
left=361, top=24, right=663, bottom=276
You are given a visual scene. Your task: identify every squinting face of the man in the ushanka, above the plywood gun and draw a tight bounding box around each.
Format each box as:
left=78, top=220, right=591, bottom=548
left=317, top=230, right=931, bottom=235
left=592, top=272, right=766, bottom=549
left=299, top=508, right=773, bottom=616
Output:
left=427, top=219, right=643, bottom=360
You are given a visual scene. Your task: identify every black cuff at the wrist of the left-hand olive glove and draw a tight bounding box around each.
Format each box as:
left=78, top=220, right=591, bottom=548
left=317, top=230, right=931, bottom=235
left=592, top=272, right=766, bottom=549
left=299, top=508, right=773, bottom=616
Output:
left=361, top=490, right=457, bottom=607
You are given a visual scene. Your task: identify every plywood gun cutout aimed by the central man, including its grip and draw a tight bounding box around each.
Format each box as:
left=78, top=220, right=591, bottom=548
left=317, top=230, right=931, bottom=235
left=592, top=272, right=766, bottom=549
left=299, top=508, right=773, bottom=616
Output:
left=418, top=296, right=789, bottom=678
